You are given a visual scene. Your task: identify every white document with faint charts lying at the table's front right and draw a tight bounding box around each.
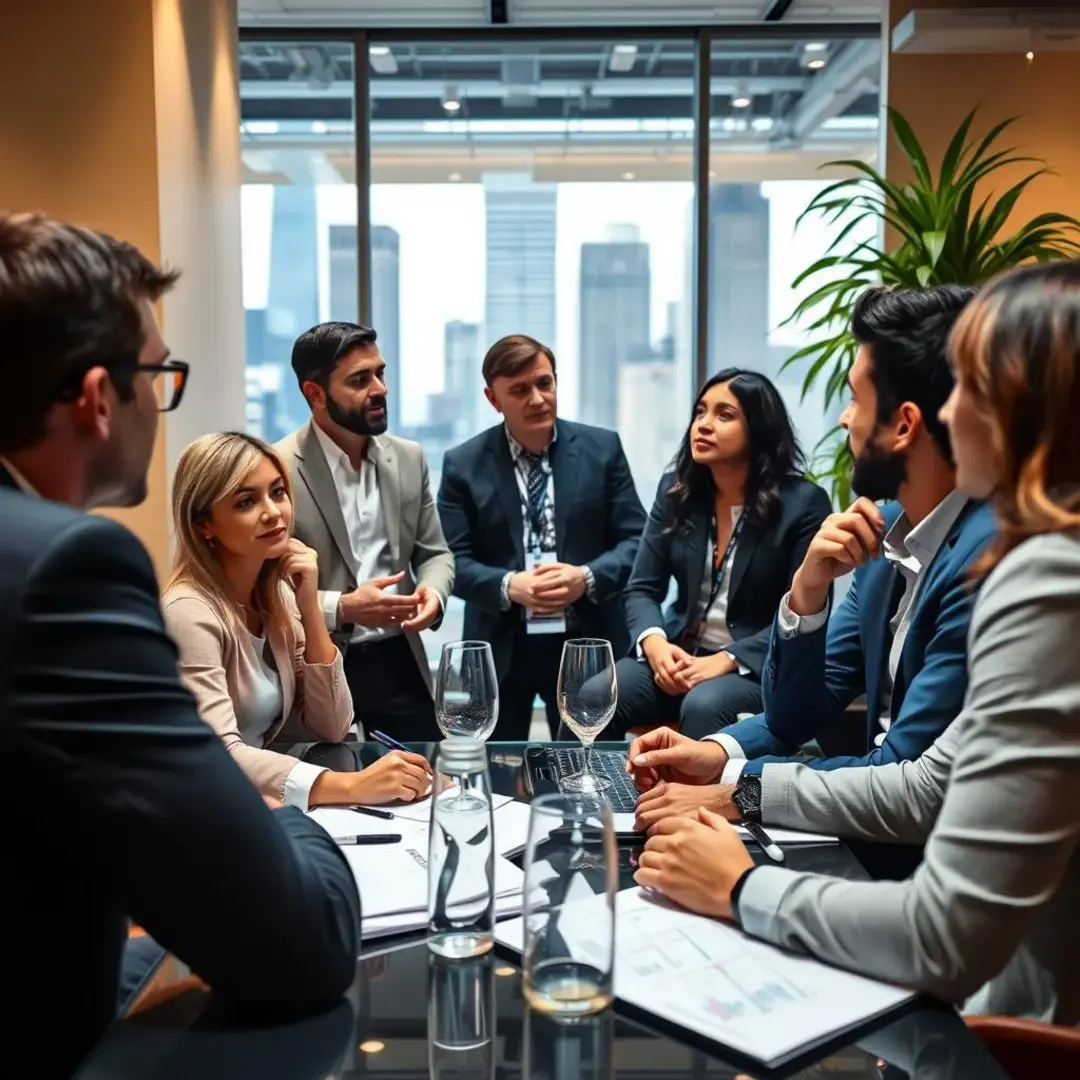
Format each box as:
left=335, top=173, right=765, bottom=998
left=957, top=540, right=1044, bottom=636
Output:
left=496, top=889, right=915, bottom=1067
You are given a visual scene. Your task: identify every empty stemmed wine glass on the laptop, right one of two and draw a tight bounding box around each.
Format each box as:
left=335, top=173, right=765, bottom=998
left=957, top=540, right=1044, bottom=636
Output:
left=556, top=637, right=619, bottom=794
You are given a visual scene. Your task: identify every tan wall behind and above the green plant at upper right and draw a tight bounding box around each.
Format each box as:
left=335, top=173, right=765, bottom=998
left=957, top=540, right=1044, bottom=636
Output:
left=887, top=0, right=1080, bottom=230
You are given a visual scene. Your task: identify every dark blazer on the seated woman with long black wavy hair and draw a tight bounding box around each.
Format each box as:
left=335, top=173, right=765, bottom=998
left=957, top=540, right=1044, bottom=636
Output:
left=625, top=473, right=831, bottom=678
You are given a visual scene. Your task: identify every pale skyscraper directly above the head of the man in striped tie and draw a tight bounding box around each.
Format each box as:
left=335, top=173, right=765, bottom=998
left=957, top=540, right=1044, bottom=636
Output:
left=484, top=173, right=555, bottom=348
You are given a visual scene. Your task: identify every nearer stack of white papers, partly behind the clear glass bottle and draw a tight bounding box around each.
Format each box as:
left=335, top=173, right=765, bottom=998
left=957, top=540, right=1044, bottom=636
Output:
left=309, top=807, right=525, bottom=939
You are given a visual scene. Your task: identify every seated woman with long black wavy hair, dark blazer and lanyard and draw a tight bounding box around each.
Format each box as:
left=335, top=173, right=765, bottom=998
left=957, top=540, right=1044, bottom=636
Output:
left=612, top=367, right=829, bottom=738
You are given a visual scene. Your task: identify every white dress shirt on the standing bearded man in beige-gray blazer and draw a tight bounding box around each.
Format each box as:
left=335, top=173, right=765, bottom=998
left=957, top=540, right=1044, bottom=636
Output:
left=311, top=423, right=401, bottom=643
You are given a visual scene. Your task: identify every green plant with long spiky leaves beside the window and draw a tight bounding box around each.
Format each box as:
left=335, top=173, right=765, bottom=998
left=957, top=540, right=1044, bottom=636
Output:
left=782, top=108, right=1080, bottom=507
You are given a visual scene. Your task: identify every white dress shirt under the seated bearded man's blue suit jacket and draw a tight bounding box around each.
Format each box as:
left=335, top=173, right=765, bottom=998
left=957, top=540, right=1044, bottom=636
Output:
left=706, top=490, right=968, bottom=784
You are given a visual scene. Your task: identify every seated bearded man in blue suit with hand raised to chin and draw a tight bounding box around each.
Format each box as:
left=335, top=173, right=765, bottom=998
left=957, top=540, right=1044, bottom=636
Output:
left=631, top=285, right=994, bottom=825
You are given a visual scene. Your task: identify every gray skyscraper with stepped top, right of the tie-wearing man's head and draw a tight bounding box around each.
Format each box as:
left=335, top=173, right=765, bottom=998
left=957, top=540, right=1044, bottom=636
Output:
left=578, top=225, right=651, bottom=428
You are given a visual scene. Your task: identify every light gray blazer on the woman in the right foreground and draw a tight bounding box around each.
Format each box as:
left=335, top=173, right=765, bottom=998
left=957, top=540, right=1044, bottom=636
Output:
left=738, top=535, right=1080, bottom=1024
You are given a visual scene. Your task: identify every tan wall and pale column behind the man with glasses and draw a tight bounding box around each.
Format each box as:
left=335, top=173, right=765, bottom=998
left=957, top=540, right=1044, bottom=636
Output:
left=0, top=0, right=244, bottom=573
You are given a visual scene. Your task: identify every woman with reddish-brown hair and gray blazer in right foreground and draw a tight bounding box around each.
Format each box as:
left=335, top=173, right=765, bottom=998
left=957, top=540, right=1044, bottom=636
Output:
left=631, top=261, right=1080, bottom=1024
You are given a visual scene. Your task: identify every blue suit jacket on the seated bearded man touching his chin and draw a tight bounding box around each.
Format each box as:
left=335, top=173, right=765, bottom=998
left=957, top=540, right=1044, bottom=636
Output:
left=724, top=501, right=995, bottom=773
